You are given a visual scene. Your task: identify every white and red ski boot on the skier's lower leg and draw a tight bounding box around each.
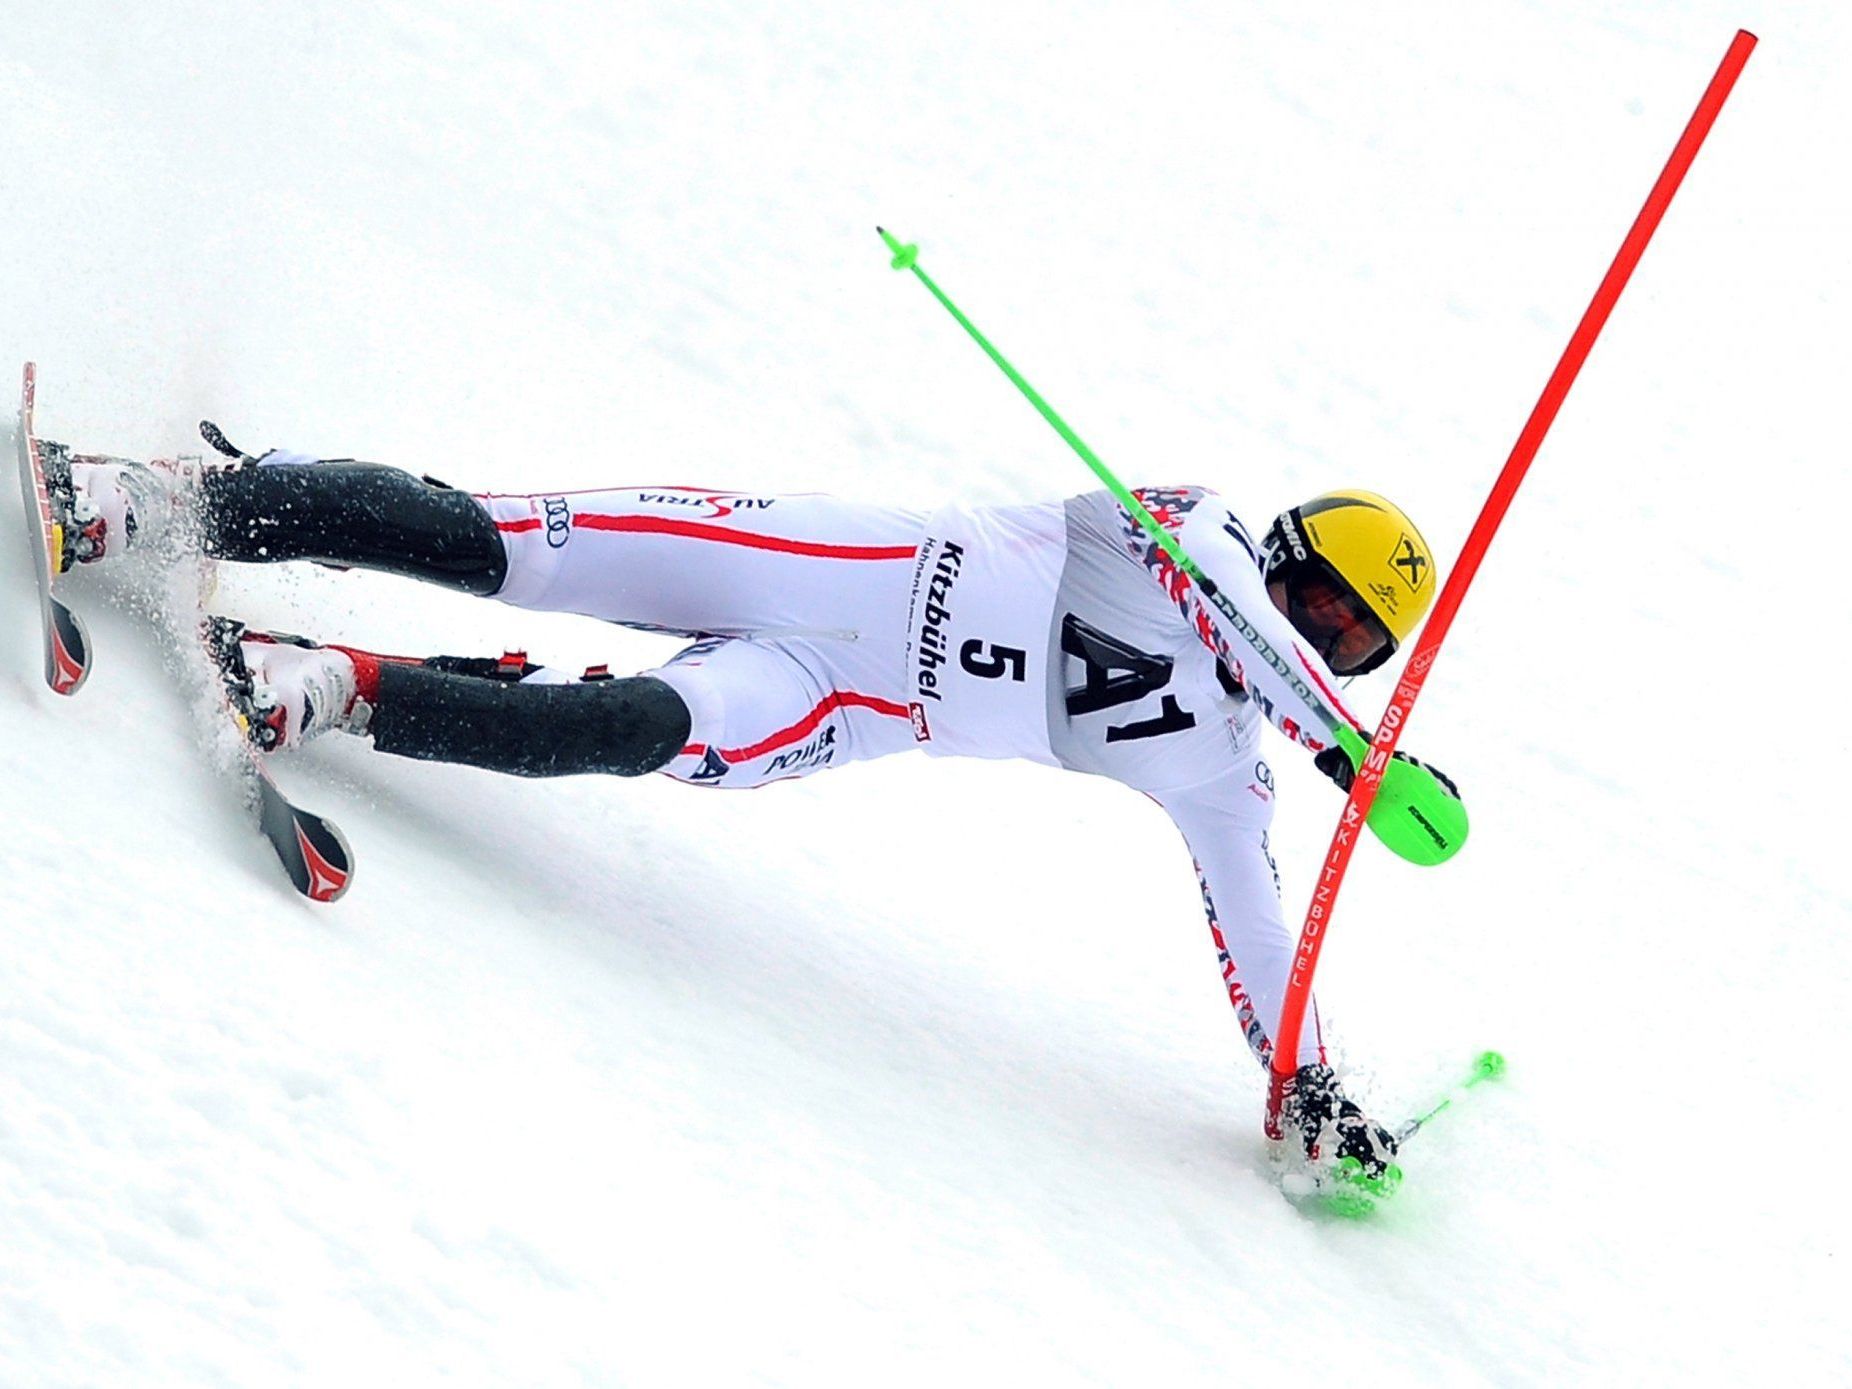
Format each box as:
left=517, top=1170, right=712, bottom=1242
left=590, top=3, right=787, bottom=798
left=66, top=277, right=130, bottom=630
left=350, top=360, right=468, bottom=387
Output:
left=206, top=617, right=372, bottom=752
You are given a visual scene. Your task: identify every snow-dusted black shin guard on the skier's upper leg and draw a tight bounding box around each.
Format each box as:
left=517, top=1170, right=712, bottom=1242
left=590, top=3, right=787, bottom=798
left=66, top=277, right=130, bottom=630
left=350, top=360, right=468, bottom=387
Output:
left=202, top=463, right=507, bottom=596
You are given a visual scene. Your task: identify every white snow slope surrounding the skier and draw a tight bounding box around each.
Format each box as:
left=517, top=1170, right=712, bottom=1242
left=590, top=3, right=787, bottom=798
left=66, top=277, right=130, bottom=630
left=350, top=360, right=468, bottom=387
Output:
left=0, top=0, right=1852, bottom=1385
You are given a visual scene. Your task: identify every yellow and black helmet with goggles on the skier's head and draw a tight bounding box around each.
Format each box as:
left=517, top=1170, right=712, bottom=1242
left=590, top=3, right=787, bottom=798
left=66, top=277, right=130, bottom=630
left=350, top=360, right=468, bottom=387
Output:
left=1265, top=489, right=1439, bottom=676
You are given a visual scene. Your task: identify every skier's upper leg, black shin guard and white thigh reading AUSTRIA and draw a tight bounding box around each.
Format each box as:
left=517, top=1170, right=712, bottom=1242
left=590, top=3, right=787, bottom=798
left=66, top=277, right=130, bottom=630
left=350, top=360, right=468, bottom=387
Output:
left=202, top=468, right=924, bottom=639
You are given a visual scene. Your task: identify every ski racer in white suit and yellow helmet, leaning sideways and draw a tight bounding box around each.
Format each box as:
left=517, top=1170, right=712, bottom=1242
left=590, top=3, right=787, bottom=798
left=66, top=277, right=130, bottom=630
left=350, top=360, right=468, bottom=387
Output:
left=54, top=440, right=1458, bottom=1174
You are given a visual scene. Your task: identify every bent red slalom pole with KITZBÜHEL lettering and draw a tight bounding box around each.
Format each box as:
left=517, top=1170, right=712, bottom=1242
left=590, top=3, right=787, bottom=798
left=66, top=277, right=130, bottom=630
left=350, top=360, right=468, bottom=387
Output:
left=1267, top=30, right=1756, bottom=1141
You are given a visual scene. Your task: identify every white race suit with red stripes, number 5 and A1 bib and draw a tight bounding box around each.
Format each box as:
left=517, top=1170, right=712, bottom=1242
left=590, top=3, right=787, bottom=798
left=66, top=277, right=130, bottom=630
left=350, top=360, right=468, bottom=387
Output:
left=478, top=487, right=1377, bottom=1065
